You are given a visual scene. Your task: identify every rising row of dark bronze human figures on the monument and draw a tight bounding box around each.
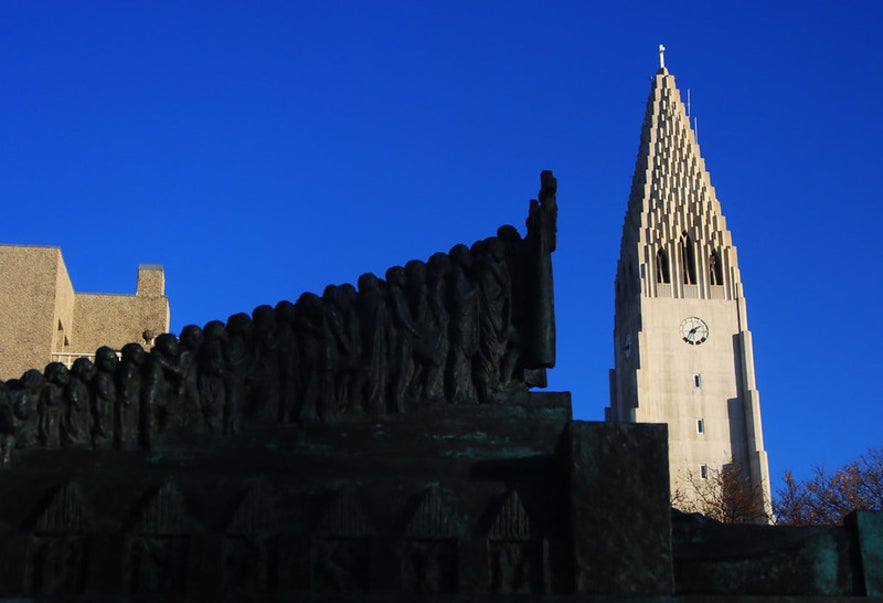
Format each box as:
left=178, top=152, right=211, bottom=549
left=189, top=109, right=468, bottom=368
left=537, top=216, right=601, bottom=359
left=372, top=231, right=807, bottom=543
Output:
left=0, top=172, right=557, bottom=462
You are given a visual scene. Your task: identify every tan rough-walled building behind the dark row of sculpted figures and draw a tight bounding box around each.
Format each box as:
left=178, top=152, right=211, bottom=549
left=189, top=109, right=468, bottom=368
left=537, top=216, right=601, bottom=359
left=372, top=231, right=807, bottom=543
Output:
left=0, top=245, right=169, bottom=379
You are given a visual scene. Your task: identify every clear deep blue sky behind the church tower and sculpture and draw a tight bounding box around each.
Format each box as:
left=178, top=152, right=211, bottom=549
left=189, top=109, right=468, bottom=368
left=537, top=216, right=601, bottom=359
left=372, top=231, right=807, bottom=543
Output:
left=0, top=0, right=883, bottom=488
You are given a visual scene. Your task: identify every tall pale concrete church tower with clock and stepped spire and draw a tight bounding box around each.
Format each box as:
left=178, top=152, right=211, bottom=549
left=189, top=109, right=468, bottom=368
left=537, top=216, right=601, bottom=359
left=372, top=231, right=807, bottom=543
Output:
left=606, top=46, right=770, bottom=512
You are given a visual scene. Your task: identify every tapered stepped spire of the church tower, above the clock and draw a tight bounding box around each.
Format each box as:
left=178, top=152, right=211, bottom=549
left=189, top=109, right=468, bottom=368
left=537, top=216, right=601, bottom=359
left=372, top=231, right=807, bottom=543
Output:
left=621, top=61, right=741, bottom=306
